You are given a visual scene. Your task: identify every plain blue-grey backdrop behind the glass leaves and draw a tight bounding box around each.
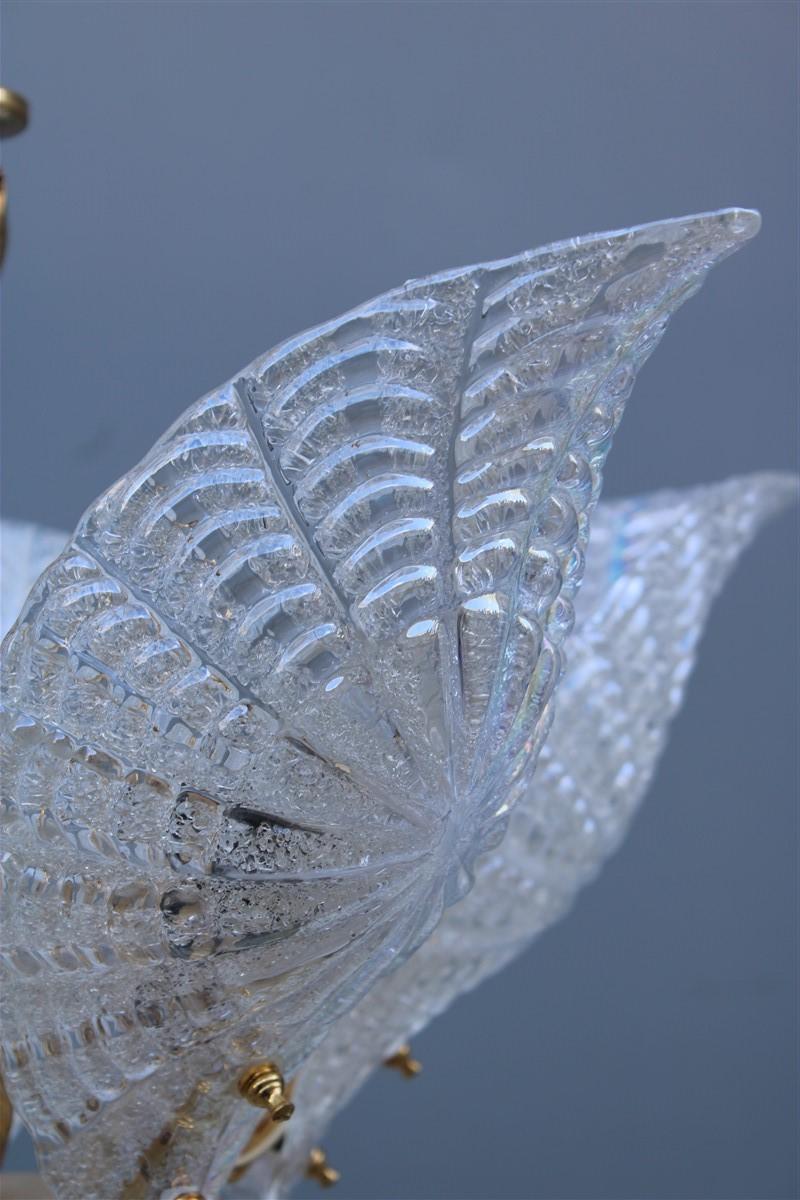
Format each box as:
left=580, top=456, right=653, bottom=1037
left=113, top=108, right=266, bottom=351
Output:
left=2, top=0, right=798, bottom=1200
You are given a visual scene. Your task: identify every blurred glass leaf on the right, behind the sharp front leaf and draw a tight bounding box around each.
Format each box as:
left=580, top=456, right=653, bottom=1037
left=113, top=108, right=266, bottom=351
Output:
left=244, top=474, right=798, bottom=1196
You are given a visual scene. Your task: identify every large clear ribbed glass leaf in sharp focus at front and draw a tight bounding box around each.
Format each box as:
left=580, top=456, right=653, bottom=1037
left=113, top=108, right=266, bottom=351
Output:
left=2, top=210, right=758, bottom=1198
